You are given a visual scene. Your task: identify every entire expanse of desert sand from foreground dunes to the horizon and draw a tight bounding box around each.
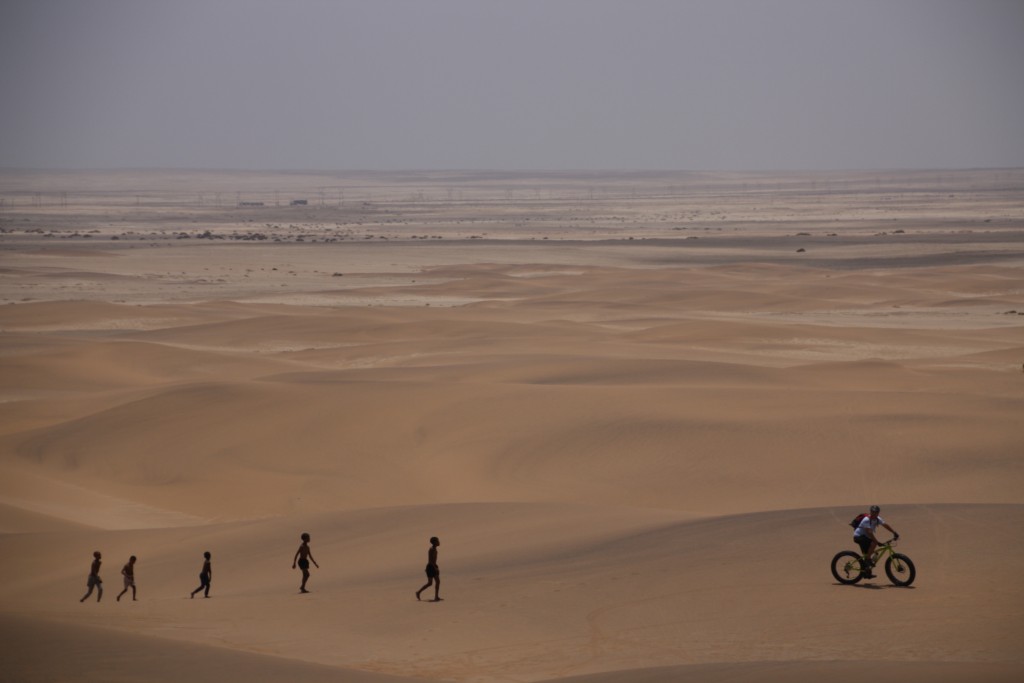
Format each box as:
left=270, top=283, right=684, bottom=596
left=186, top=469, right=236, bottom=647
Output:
left=0, top=170, right=1024, bottom=683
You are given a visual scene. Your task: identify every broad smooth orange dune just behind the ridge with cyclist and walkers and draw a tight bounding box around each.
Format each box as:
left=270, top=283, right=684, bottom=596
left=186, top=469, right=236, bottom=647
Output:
left=6, top=342, right=1024, bottom=516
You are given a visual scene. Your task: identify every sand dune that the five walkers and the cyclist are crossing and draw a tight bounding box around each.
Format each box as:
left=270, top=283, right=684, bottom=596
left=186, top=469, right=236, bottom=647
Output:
left=0, top=504, right=1024, bottom=680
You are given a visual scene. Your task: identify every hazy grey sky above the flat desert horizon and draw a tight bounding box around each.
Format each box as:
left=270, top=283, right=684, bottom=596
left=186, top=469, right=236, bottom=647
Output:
left=6, top=0, right=1024, bottom=170
